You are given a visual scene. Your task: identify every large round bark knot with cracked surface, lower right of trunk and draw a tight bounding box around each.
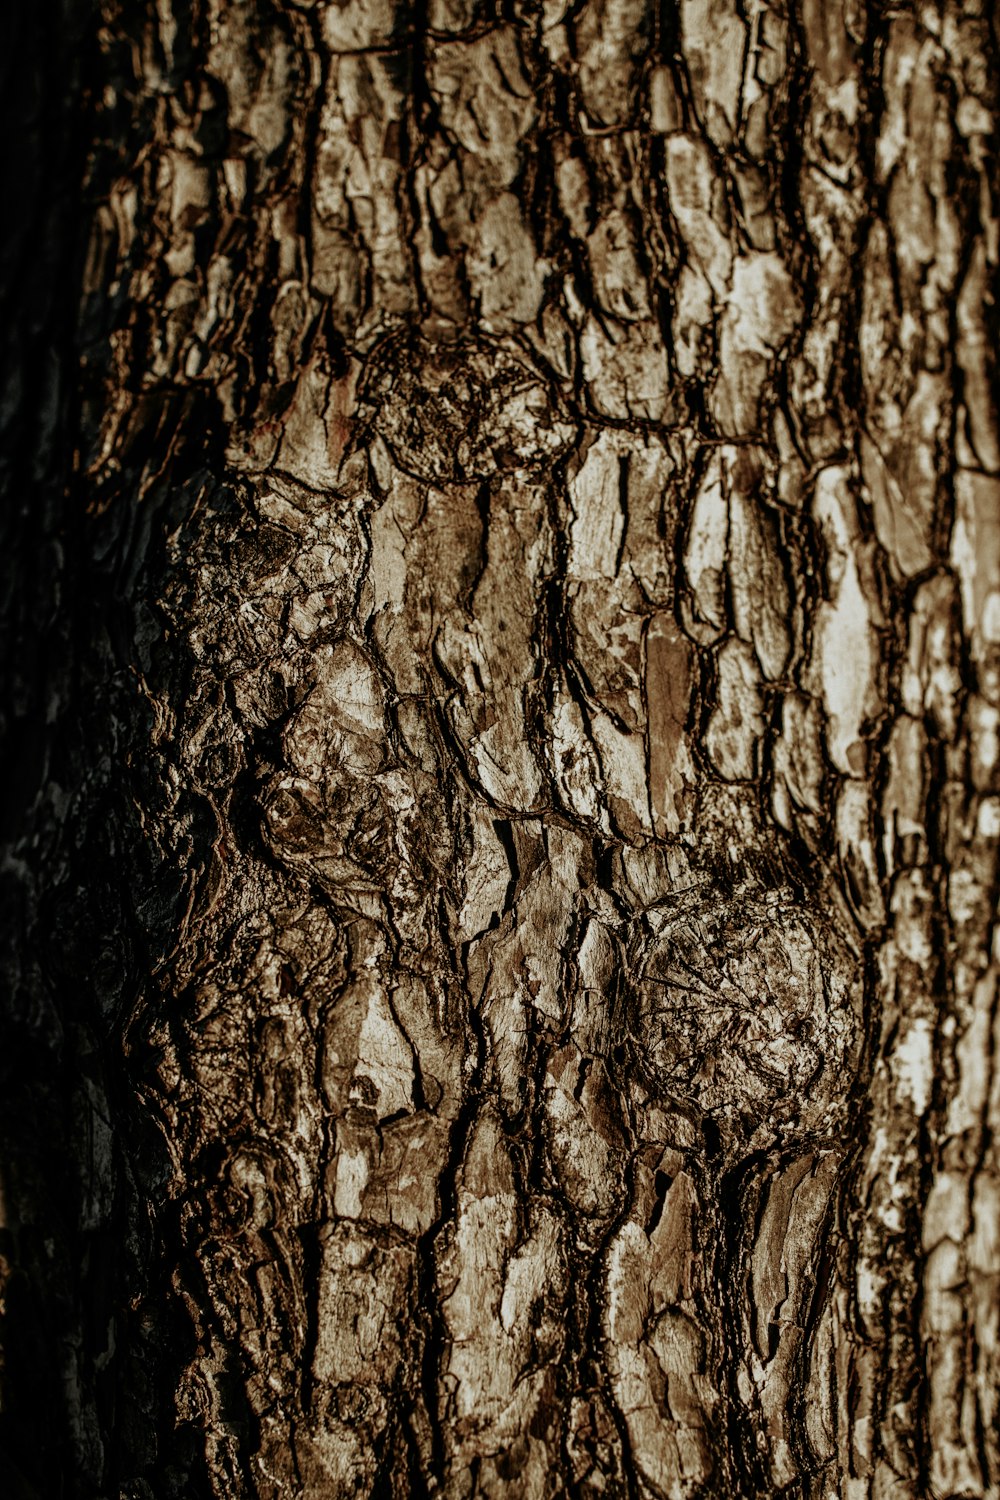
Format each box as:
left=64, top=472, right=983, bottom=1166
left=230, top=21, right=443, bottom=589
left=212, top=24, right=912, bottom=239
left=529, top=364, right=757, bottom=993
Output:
left=633, top=893, right=861, bottom=1149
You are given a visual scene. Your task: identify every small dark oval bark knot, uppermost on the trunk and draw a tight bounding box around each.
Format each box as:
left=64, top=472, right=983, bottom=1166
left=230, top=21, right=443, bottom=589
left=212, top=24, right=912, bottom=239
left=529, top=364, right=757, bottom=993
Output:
left=360, top=335, right=576, bottom=485
